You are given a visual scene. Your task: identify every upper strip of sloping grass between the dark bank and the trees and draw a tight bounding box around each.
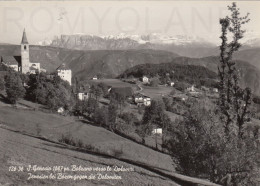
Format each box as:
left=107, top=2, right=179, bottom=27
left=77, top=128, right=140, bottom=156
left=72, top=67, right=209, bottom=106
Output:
left=0, top=103, right=177, bottom=171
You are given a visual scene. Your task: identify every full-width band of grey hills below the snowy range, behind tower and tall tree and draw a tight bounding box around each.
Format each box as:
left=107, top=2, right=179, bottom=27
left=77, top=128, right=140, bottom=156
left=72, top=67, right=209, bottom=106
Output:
left=0, top=45, right=260, bottom=95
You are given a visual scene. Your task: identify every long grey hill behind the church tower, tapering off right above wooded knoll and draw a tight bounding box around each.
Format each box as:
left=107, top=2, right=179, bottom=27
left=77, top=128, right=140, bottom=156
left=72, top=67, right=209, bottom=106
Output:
left=0, top=45, right=179, bottom=78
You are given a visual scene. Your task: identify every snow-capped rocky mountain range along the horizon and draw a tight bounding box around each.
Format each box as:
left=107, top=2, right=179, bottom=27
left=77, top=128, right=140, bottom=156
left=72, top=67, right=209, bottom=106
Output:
left=49, top=33, right=260, bottom=58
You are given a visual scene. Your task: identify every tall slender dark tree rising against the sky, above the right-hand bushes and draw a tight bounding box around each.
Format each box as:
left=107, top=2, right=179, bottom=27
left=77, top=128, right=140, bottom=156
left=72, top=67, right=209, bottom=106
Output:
left=218, top=3, right=251, bottom=137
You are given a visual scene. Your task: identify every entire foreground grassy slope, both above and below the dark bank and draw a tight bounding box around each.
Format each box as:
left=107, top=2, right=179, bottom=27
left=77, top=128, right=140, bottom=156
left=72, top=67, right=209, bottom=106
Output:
left=0, top=96, right=221, bottom=186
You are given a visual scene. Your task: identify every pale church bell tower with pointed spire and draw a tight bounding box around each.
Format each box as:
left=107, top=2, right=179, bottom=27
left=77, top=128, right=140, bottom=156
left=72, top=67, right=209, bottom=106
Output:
left=21, top=29, right=30, bottom=74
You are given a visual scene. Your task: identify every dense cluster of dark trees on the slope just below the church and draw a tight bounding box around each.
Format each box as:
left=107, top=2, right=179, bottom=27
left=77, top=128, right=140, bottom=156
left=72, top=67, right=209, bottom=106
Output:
left=1, top=69, right=75, bottom=111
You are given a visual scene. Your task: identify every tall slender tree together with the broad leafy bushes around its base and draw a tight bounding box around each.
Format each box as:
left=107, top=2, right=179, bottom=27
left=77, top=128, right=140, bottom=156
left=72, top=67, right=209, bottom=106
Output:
left=167, top=3, right=260, bottom=186
